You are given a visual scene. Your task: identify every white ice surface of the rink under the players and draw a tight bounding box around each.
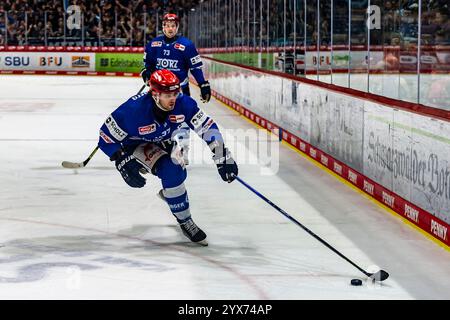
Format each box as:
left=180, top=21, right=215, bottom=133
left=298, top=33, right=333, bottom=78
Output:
left=0, top=75, right=450, bottom=299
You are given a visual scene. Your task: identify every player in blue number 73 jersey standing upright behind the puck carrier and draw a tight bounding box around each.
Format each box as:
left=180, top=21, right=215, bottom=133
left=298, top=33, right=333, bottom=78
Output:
left=141, top=13, right=211, bottom=164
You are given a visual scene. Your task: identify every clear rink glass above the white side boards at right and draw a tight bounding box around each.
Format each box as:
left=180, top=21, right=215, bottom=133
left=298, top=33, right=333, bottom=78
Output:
left=185, top=0, right=450, bottom=110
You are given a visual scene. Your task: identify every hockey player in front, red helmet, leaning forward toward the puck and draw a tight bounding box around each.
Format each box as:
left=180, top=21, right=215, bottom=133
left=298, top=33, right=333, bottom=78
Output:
left=98, top=70, right=238, bottom=245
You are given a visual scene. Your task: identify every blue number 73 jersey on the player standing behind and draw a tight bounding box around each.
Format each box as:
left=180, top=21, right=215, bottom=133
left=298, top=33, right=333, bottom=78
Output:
left=144, top=36, right=205, bottom=87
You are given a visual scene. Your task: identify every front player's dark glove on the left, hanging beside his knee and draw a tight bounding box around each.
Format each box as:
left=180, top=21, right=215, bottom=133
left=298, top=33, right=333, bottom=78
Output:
left=111, top=150, right=146, bottom=188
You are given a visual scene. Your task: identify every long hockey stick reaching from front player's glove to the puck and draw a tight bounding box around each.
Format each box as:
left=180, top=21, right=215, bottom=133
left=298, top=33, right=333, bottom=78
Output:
left=236, top=176, right=389, bottom=281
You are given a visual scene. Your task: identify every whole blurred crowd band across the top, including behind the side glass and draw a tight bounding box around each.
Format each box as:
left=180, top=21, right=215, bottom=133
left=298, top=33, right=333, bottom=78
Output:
left=0, top=0, right=450, bottom=46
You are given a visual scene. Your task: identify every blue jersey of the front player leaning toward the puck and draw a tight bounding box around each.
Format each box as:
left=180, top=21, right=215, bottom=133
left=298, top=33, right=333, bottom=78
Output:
left=98, top=93, right=223, bottom=157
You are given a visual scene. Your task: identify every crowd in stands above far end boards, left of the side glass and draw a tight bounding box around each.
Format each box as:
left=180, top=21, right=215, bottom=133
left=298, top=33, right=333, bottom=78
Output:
left=0, top=0, right=200, bottom=46
